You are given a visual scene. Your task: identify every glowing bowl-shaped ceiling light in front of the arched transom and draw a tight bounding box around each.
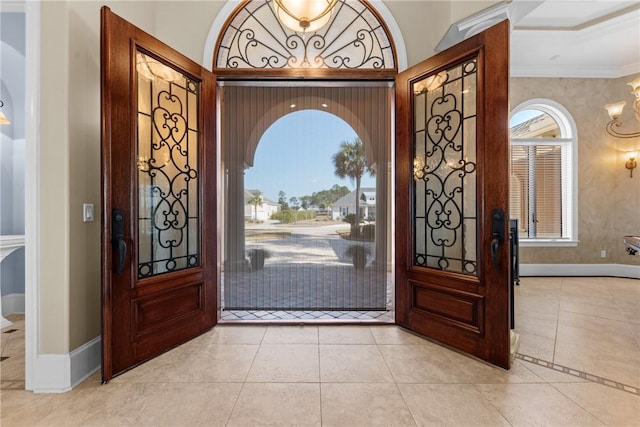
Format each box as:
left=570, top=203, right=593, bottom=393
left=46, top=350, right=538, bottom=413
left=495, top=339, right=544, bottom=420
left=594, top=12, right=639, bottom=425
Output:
left=274, top=0, right=338, bottom=33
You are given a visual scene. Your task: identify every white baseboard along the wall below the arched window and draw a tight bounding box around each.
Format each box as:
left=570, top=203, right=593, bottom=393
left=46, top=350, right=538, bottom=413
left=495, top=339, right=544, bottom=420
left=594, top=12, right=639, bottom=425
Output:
left=520, top=264, right=640, bottom=279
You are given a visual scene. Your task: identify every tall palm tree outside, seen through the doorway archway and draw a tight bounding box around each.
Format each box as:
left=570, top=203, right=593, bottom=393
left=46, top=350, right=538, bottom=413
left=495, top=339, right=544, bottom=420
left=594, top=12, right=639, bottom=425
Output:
left=332, top=137, right=375, bottom=237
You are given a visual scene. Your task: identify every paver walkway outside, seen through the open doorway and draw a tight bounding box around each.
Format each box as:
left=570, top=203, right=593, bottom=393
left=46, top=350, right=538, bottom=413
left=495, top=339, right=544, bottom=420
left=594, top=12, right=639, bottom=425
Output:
left=224, top=225, right=387, bottom=311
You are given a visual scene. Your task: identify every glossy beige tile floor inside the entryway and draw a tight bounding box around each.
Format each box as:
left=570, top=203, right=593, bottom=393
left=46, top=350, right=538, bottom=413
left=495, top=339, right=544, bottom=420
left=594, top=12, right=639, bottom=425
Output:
left=0, top=278, right=640, bottom=427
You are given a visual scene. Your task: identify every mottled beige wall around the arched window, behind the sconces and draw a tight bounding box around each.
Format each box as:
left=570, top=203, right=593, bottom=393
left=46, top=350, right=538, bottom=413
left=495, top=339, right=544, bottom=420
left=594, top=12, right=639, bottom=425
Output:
left=510, top=76, right=640, bottom=265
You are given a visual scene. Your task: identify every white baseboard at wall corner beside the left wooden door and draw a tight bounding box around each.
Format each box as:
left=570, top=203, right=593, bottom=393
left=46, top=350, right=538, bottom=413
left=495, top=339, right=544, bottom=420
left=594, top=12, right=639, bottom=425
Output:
left=32, top=337, right=102, bottom=393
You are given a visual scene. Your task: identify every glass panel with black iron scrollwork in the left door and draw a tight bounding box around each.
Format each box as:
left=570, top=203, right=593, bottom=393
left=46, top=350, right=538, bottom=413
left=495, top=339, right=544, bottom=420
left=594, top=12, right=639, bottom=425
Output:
left=136, top=52, right=200, bottom=278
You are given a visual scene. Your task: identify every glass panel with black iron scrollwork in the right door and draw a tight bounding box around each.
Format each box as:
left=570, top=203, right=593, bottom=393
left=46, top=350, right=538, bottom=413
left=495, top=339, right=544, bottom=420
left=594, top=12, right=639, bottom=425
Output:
left=412, top=58, right=478, bottom=275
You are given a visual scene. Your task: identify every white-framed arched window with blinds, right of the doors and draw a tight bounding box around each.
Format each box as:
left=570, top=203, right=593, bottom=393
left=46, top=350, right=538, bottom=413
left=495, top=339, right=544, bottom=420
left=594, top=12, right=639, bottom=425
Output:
left=509, top=99, right=578, bottom=246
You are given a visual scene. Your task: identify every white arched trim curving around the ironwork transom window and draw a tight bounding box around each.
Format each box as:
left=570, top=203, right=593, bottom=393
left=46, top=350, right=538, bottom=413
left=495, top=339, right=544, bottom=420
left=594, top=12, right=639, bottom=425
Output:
left=202, top=0, right=409, bottom=71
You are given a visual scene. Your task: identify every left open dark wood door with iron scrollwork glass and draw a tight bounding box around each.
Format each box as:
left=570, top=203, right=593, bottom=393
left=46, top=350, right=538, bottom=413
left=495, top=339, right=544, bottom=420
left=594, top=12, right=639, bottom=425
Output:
left=101, top=6, right=219, bottom=381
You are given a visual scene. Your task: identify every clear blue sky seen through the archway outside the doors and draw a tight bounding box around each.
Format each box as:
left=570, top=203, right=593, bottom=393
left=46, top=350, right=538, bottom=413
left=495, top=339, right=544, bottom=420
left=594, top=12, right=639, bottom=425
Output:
left=244, top=110, right=375, bottom=202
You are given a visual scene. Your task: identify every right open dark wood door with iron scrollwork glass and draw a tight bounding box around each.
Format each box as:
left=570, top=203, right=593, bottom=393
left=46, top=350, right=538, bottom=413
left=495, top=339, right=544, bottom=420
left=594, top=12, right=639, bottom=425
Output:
left=395, top=21, right=510, bottom=369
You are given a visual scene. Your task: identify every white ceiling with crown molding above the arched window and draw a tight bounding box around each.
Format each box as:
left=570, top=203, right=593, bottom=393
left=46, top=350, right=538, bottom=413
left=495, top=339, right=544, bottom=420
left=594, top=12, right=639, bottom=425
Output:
left=509, top=0, right=640, bottom=78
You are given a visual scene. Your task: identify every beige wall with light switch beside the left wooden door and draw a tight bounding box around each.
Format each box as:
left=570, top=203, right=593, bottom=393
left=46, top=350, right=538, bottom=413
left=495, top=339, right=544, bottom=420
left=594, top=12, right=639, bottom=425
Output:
left=38, top=1, right=161, bottom=354
